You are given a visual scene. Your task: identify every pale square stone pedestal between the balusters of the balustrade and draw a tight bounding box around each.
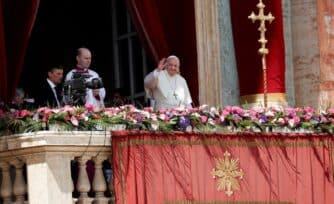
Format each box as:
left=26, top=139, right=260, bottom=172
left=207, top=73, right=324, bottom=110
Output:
left=26, top=152, right=73, bottom=204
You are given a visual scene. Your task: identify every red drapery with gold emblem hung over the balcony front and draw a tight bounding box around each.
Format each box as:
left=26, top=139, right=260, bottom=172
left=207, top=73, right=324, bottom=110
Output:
left=112, top=131, right=334, bottom=204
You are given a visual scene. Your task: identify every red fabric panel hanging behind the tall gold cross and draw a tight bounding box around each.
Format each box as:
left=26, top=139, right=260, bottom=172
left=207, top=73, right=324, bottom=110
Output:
left=230, top=0, right=285, bottom=96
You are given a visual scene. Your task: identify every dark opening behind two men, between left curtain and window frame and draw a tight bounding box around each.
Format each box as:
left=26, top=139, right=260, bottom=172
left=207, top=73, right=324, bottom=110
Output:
left=20, top=0, right=113, bottom=101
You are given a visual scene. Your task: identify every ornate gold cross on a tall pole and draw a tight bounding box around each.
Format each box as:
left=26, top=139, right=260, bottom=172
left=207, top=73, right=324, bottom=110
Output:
left=248, top=0, right=275, bottom=108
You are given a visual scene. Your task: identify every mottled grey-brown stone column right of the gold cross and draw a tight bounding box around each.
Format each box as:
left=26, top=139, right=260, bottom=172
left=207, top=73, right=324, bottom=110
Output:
left=291, top=0, right=321, bottom=108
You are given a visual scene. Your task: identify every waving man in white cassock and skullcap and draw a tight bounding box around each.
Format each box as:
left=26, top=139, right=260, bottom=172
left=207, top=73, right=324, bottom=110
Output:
left=144, top=55, right=192, bottom=110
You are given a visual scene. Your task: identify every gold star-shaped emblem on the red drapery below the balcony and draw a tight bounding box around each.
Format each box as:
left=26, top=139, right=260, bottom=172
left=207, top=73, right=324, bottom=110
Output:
left=211, top=151, right=244, bottom=196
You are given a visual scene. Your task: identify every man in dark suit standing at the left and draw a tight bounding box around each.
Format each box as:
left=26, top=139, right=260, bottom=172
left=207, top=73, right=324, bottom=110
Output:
left=35, top=66, right=64, bottom=108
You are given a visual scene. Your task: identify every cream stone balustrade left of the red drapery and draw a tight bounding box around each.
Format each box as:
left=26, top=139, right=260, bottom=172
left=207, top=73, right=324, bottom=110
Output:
left=0, top=131, right=115, bottom=204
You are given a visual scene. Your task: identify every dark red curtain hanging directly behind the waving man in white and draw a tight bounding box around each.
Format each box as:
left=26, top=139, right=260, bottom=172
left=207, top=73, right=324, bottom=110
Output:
left=127, top=0, right=198, bottom=104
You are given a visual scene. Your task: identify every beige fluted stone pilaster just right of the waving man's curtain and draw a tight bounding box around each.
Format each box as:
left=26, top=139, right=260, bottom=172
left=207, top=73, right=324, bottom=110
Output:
left=195, top=0, right=223, bottom=106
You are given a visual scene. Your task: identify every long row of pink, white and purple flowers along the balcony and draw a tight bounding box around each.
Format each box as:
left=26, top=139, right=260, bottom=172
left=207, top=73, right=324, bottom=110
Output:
left=0, top=105, right=334, bottom=135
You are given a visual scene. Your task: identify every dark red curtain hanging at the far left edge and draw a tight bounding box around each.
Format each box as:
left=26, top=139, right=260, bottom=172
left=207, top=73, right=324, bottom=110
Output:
left=0, top=0, right=40, bottom=102
